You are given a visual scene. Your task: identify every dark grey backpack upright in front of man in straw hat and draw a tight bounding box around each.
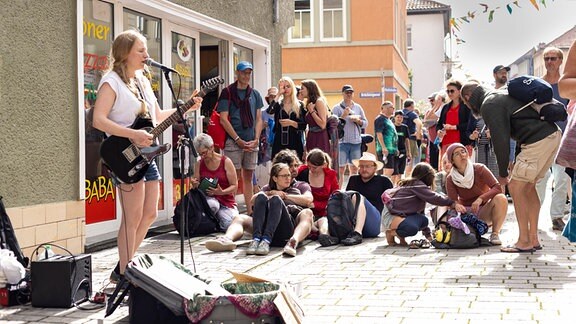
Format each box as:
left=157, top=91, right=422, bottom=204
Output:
left=326, top=190, right=360, bottom=240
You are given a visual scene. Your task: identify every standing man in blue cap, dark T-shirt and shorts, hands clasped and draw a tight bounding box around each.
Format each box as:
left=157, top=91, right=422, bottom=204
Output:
left=218, top=61, right=264, bottom=214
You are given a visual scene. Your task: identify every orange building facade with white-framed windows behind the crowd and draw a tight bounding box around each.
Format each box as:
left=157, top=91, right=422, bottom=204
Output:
left=282, top=0, right=410, bottom=151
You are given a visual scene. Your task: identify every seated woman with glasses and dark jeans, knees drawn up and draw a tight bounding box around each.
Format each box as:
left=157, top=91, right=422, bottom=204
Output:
left=246, top=163, right=312, bottom=255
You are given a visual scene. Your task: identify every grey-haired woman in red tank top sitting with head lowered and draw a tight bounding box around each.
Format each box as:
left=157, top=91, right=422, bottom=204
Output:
left=191, top=134, right=238, bottom=231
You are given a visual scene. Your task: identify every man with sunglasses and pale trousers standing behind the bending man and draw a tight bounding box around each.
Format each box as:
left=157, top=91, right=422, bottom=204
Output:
left=536, top=47, right=570, bottom=231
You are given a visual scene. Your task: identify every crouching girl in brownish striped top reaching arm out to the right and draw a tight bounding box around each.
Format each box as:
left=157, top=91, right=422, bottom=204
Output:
left=382, top=162, right=466, bottom=247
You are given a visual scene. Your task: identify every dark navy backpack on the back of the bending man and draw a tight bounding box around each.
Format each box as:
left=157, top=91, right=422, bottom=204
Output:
left=508, top=75, right=568, bottom=122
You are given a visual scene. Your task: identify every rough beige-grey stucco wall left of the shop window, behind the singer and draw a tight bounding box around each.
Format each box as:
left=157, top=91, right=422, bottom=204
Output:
left=0, top=0, right=78, bottom=207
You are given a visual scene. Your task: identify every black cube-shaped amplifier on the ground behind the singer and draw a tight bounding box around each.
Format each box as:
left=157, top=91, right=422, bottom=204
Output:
left=30, top=254, right=92, bottom=308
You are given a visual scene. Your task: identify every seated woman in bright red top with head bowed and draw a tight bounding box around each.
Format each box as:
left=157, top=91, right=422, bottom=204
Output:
left=296, top=149, right=340, bottom=246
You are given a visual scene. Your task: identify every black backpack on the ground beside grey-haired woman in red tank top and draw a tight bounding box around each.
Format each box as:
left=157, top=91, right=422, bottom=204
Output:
left=172, top=189, right=221, bottom=237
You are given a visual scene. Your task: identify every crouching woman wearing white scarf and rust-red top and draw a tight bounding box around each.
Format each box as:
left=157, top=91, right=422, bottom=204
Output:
left=446, top=143, right=508, bottom=245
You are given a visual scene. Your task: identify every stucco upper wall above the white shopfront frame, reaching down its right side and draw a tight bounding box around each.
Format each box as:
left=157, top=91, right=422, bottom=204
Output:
left=166, top=0, right=294, bottom=83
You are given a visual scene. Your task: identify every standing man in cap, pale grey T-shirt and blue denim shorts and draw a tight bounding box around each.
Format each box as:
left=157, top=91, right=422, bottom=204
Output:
left=332, top=84, right=368, bottom=186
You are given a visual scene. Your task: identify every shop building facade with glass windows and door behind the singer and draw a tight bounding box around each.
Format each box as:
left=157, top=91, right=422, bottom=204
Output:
left=0, top=0, right=294, bottom=255
